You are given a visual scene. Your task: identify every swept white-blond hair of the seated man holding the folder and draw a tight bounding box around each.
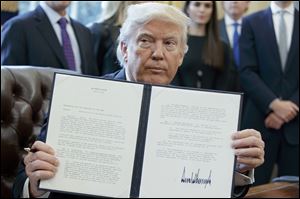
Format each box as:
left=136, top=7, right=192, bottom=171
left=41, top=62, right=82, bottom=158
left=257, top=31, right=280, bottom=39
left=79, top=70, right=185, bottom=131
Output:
left=117, top=2, right=190, bottom=66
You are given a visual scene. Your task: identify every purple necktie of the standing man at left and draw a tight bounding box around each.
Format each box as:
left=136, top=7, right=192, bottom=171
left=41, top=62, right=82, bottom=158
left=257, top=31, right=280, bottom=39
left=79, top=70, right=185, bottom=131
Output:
left=58, top=17, right=75, bottom=70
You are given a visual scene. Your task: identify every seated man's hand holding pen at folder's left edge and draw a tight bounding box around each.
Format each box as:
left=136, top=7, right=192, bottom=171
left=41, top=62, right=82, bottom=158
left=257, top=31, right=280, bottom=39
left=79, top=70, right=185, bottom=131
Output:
left=24, top=141, right=58, bottom=197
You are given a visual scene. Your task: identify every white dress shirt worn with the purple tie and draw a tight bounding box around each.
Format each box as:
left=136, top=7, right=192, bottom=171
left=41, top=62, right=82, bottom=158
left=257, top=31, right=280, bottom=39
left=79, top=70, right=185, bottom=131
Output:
left=40, top=1, right=81, bottom=73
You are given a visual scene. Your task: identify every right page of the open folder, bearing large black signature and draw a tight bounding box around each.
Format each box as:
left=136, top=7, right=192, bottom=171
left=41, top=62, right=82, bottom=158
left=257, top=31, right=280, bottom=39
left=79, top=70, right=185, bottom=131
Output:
left=140, top=86, right=241, bottom=198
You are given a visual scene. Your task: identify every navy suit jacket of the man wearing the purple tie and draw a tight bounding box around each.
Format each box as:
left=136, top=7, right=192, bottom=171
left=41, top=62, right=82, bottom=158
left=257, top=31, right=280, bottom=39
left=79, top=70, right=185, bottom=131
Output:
left=1, top=6, right=99, bottom=75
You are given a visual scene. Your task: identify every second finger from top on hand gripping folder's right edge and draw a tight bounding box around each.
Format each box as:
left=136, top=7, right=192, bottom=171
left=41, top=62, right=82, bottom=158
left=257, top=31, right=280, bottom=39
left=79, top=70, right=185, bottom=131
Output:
left=232, top=136, right=265, bottom=149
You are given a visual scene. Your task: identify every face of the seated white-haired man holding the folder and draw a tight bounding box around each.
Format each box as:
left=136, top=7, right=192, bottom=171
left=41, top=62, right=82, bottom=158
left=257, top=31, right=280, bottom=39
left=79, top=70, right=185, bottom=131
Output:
left=121, top=20, right=185, bottom=84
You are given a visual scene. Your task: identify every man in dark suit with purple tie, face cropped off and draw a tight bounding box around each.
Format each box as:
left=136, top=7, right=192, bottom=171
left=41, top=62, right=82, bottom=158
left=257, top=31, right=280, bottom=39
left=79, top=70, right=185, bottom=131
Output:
left=1, top=1, right=99, bottom=75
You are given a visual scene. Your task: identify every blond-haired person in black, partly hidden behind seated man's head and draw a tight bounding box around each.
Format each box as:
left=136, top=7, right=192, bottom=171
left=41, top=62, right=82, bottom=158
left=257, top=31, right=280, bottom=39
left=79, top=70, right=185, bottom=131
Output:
left=89, top=1, right=142, bottom=75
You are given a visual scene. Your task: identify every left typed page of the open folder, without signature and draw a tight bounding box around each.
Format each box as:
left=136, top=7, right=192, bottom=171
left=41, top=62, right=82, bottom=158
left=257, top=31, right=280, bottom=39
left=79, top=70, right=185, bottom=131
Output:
left=40, top=74, right=143, bottom=197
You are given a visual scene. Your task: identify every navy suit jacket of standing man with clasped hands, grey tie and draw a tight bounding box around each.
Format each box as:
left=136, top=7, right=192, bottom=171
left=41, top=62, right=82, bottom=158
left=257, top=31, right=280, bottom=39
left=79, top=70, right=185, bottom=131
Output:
left=240, top=8, right=299, bottom=145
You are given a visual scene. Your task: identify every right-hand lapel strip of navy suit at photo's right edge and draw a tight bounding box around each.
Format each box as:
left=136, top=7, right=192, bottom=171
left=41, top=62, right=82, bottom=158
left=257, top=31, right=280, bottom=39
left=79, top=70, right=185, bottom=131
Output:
left=285, top=10, right=299, bottom=71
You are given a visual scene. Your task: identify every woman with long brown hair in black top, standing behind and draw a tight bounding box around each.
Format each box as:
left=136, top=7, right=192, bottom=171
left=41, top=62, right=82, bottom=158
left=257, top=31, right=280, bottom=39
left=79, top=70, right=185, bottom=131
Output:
left=173, top=1, right=234, bottom=91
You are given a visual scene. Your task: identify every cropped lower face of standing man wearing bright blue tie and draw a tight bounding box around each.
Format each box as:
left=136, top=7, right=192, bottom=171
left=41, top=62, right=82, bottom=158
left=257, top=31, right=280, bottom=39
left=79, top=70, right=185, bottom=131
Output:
left=223, top=1, right=250, bottom=18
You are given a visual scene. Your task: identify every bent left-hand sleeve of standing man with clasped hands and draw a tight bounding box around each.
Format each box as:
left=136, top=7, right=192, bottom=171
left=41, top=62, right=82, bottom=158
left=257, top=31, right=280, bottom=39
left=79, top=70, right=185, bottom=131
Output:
left=240, top=18, right=277, bottom=114
